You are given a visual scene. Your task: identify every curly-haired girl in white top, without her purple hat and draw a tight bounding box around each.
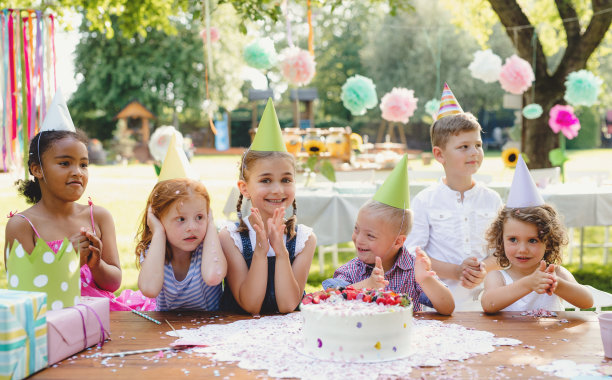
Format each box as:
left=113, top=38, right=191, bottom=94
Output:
left=481, top=204, right=593, bottom=313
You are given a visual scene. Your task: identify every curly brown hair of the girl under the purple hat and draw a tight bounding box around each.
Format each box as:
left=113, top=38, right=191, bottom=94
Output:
left=486, top=204, right=568, bottom=268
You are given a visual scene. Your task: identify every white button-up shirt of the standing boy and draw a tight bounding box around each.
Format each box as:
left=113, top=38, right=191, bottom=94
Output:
left=404, top=179, right=502, bottom=310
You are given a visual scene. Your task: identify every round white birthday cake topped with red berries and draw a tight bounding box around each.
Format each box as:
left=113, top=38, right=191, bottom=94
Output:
left=300, top=286, right=412, bottom=362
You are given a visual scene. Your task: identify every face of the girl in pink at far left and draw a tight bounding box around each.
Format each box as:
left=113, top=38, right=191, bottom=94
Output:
left=32, top=137, right=89, bottom=202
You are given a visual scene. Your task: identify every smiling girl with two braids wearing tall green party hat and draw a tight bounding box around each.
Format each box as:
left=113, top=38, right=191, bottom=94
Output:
left=219, top=101, right=316, bottom=314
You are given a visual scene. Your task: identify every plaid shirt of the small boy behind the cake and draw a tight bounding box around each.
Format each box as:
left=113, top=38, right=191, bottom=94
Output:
left=323, top=247, right=433, bottom=311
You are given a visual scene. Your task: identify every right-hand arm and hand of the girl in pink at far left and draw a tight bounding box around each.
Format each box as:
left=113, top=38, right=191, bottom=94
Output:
left=82, top=206, right=121, bottom=292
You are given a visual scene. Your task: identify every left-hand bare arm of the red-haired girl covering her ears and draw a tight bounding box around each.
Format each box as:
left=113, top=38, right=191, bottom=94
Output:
left=138, top=206, right=166, bottom=298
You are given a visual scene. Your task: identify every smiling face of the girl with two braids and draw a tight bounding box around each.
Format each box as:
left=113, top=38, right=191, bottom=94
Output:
left=238, top=158, right=295, bottom=221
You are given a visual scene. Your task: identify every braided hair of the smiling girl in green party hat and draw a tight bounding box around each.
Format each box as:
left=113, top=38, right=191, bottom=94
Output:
left=236, top=149, right=297, bottom=240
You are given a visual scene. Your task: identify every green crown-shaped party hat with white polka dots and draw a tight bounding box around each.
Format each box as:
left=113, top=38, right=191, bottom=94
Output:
left=6, top=238, right=81, bottom=310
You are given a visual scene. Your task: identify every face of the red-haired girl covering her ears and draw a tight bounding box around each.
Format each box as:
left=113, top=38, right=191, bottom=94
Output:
left=161, top=195, right=208, bottom=254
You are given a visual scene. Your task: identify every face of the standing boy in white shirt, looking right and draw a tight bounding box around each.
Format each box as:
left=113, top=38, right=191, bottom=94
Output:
left=434, top=130, right=484, bottom=176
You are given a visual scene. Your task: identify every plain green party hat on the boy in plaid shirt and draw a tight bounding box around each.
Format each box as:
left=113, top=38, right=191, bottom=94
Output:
left=373, top=154, right=410, bottom=210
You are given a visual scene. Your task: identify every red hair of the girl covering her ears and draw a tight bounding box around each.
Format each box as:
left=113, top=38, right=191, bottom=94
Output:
left=136, top=178, right=210, bottom=268
